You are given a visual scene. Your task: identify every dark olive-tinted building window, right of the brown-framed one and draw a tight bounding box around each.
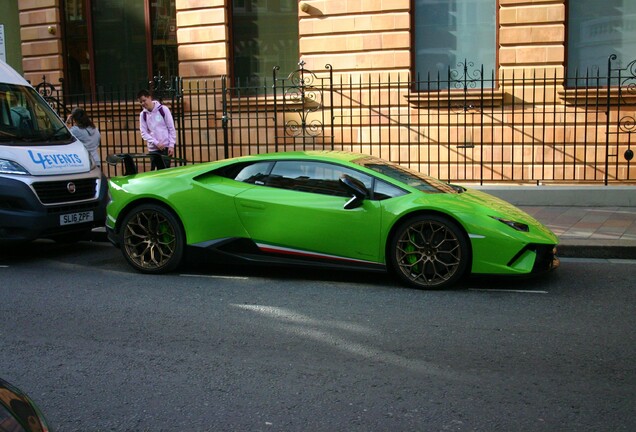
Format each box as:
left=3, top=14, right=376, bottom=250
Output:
left=232, top=0, right=298, bottom=86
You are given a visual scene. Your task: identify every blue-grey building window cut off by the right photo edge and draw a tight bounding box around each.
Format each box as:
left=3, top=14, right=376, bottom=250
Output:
left=568, top=0, right=636, bottom=87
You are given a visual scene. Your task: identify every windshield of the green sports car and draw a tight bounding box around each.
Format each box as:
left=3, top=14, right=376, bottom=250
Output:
left=353, top=156, right=458, bottom=193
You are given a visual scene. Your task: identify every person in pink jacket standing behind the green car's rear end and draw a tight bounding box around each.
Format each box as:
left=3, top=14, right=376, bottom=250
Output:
left=137, top=90, right=177, bottom=170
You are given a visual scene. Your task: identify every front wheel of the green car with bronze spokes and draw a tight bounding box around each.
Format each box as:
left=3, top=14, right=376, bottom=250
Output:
left=389, top=215, right=469, bottom=289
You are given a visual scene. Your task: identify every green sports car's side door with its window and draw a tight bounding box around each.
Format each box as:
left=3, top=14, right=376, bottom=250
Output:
left=236, top=160, right=382, bottom=262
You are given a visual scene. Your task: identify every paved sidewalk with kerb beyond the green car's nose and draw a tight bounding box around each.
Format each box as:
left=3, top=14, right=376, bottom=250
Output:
left=468, top=185, right=636, bottom=259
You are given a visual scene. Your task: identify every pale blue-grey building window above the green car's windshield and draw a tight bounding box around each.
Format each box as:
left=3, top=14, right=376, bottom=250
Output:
left=413, top=0, right=497, bottom=90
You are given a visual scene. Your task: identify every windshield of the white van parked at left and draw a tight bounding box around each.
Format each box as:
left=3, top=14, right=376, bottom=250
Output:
left=0, top=83, right=73, bottom=146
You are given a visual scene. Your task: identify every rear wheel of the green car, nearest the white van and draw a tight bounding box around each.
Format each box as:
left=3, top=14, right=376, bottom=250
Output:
left=120, top=204, right=185, bottom=273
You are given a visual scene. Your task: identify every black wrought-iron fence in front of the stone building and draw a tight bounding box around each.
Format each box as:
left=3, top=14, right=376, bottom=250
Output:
left=40, top=56, right=636, bottom=184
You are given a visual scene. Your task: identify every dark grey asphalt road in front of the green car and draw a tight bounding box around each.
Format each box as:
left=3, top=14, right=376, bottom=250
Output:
left=0, top=242, right=636, bottom=432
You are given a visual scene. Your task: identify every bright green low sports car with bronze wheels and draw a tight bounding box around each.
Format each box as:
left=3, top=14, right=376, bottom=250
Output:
left=106, top=151, right=559, bottom=288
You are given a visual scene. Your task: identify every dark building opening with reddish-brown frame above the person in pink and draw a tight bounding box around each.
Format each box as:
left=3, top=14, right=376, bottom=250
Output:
left=62, top=0, right=178, bottom=95
